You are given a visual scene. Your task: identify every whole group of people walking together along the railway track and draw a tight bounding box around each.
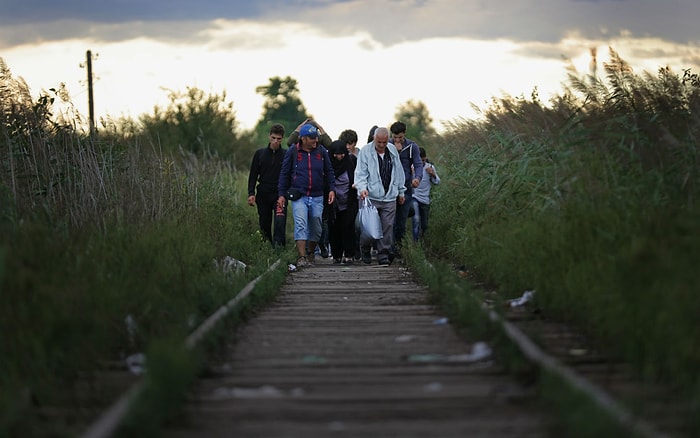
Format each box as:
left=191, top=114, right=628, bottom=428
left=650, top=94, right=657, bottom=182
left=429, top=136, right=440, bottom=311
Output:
left=248, top=119, right=440, bottom=267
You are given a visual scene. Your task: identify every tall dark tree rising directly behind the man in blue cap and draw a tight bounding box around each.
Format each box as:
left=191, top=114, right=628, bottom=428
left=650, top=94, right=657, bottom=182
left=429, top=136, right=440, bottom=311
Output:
left=254, top=76, right=308, bottom=144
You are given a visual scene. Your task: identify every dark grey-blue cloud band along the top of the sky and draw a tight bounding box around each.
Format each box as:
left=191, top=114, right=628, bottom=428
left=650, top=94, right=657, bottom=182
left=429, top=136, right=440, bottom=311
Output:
left=0, top=0, right=700, bottom=47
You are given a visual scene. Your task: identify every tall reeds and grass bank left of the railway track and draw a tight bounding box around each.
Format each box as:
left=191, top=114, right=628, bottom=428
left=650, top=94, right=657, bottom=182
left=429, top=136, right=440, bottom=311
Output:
left=0, top=60, right=280, bottom=436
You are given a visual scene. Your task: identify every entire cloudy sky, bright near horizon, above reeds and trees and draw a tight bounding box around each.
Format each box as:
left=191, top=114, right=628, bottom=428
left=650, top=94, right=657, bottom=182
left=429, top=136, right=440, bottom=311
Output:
left=0, top=0, right=700, bottom=137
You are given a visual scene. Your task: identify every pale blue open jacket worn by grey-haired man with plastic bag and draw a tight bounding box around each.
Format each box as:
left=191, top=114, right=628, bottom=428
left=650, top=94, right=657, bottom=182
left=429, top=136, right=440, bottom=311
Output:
left=355, top=142, right=406, bottom=202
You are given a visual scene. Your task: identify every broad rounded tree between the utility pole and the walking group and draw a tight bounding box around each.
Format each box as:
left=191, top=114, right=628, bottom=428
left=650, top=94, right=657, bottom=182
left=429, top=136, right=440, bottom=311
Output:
left=140, top=87, right=238, bottom=159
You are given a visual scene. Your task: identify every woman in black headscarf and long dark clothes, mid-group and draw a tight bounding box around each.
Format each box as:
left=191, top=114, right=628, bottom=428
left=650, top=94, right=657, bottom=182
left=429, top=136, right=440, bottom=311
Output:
left=328, top=140, right=358, bottom=263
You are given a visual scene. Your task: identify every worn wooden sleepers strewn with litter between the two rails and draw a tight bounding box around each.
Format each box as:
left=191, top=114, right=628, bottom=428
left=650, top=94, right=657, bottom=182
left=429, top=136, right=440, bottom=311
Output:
left=164, top=259, right=546, bottom=437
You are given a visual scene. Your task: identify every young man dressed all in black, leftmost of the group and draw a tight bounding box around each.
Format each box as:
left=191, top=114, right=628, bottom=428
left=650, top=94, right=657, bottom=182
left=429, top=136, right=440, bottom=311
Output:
left=248, top=123, right=287, bottom=247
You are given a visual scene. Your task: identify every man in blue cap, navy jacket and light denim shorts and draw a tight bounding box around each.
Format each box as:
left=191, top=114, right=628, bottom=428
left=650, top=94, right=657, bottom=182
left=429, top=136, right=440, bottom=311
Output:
left=277, top=123, right=335, bottom=267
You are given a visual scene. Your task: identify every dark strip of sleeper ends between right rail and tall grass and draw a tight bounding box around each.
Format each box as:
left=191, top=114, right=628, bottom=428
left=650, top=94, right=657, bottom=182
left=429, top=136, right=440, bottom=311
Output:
left=504, top=298, right=700, bottom=437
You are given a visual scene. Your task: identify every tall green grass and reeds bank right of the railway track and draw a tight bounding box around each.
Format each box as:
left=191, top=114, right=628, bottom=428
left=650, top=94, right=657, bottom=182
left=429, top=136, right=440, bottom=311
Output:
left=426, top=50, right=700, bottom=414
